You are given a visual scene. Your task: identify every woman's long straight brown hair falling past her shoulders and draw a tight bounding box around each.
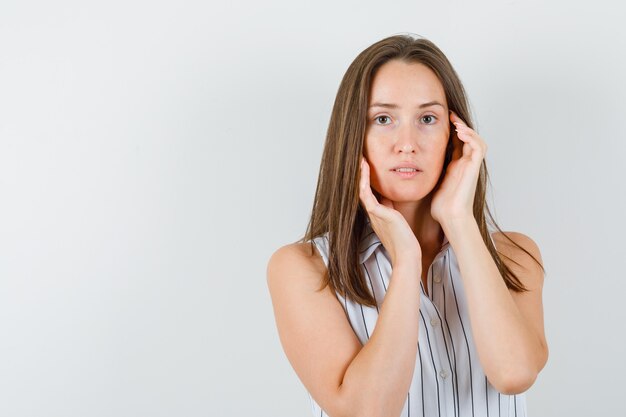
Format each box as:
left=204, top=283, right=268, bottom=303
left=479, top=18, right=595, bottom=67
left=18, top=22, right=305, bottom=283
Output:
left=299, top=35, right=543, bottom=307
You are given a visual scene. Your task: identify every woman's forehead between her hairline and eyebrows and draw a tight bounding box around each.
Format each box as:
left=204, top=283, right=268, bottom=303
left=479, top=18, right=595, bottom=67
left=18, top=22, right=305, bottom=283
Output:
left=369, top=60, right=446, bottom=105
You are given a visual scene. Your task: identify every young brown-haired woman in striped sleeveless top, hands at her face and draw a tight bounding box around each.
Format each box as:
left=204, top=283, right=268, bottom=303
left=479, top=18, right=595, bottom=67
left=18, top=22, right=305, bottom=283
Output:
left=267, top=36, right=548, bottom=417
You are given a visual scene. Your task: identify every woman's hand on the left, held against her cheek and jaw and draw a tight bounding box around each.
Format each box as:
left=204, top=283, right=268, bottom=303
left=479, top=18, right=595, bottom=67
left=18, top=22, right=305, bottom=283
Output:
left=359, top=157, right=422, bottom=268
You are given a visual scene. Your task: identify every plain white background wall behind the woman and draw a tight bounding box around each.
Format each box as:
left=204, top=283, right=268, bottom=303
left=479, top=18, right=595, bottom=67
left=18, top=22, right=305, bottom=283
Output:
left=0, top=0, right=626, bottom=417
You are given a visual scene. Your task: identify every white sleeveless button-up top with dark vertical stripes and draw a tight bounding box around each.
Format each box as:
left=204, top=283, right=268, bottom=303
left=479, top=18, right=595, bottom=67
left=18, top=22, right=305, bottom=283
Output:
left=307, top=219, right=526, bottom=417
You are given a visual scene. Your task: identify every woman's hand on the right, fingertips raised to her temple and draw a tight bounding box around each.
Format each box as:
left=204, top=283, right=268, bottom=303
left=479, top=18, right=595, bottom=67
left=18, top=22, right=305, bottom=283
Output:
left=430, top=110, right=487, bottom=224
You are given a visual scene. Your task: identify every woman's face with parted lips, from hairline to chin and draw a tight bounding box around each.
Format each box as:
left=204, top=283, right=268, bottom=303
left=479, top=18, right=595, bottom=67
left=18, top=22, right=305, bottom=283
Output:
left=364, top=60, right=450, bottom=202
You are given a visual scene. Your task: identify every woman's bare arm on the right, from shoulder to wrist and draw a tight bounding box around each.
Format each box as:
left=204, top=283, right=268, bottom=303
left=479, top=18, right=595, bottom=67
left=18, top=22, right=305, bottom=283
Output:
left=442, top=218, right=548, bottom=394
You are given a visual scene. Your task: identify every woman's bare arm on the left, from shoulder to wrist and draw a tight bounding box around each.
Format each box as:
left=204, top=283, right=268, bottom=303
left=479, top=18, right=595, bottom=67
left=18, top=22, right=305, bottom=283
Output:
left=267, top=244, right=421, bottom=417
